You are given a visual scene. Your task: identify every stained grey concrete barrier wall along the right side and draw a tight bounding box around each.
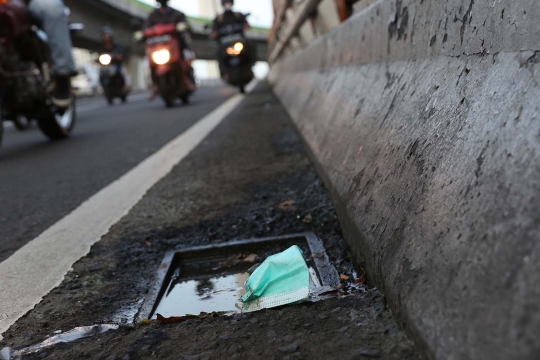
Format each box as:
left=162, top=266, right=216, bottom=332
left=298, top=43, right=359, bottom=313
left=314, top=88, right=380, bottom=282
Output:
left=271, top=0, right=540, bottom=360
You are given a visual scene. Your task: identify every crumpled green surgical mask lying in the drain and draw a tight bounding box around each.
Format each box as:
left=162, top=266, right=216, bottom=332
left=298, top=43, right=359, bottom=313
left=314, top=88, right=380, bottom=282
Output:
left=241, top=245, right=309, bottom=312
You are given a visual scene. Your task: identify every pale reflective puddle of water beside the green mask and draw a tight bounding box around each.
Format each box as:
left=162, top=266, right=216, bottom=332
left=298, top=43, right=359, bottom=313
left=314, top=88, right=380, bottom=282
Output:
left=152, top=273, right=249, bottom=319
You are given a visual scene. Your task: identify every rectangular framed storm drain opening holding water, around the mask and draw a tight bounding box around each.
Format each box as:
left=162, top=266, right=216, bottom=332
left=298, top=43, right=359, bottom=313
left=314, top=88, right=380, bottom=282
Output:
left=136, top=233, right=340, bottom=322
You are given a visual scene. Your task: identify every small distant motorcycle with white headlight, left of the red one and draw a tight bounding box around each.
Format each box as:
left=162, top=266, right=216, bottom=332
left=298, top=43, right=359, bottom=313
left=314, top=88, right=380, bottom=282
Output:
left=98, top=53, right=129, bottom=105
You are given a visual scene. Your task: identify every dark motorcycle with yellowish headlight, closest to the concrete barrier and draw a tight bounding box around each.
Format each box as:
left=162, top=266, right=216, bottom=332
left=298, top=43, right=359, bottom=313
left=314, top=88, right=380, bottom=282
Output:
left=218, top=20, right=255, bottom=94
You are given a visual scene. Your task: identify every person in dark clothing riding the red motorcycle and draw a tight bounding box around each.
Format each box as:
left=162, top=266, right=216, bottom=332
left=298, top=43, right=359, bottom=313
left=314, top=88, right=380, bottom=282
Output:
left=144, top=0, right=195, bottom=98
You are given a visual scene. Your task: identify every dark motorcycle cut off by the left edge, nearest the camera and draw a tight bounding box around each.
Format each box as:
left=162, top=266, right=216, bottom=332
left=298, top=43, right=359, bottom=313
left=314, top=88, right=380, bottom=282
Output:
left=0, top=0, right=82, bottom=152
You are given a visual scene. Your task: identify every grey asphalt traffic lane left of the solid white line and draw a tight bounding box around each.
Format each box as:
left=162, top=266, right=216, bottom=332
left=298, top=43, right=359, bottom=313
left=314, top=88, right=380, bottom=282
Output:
left=0, top=87, right=236, bottom=262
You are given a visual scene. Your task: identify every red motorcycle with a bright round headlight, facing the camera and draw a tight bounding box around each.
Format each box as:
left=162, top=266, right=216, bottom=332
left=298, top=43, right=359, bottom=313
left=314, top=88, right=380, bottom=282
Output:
left=135, top=23, right=194, bottom=107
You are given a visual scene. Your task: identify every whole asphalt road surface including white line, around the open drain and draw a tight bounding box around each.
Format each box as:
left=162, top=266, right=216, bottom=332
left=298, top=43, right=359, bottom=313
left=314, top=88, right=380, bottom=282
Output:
left=0, top=83, right=419, bottom=360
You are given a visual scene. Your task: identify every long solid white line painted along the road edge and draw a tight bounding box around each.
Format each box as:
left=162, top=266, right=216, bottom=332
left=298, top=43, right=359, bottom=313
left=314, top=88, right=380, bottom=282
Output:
left=0, top=80, right=254, bottom=340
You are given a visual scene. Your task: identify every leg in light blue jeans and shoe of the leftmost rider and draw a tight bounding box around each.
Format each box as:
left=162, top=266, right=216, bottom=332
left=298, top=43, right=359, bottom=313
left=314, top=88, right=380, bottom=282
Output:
left=25, top=0, right=77, bottom=108
